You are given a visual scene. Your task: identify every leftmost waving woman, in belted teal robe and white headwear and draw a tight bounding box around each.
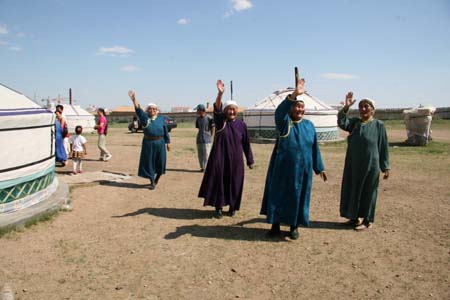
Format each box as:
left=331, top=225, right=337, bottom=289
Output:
left=128, top=91, right=170, bottom=190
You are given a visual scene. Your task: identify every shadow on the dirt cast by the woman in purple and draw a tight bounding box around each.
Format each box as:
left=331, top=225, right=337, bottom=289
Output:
left=113, top=207, right=213, bottom=220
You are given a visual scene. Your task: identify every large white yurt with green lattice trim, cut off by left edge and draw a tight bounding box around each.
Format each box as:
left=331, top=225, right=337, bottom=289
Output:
left=0, top=84, right=58, bottom=216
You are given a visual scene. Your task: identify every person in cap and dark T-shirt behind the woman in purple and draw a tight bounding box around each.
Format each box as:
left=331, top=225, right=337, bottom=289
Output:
left=195, top=104, right=216, bottom=172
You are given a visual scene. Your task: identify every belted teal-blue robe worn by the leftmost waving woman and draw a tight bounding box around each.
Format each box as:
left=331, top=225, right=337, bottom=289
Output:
left=136, top=107, right=170, bottom=180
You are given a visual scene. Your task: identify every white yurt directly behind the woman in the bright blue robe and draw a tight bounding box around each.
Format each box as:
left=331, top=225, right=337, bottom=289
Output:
left=244, top=88, right=339, bottom=142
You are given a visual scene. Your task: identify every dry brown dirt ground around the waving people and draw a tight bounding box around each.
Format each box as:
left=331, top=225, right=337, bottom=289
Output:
left=0, top=123, right=450, bottom=299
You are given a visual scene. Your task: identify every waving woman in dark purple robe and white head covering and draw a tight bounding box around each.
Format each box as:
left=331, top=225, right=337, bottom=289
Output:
left=198, top=80, right=254, bottom=219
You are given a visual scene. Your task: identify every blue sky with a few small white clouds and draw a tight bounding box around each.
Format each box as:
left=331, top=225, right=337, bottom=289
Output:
left=0, top=0, right=450, bottom=109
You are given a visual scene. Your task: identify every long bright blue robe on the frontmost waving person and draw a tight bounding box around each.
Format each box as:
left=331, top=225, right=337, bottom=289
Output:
left=261, top=98, right=325, bottom=226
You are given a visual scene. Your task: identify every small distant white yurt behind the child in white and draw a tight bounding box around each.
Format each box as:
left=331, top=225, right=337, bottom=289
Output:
left=47, top=102, right=95, bottom=134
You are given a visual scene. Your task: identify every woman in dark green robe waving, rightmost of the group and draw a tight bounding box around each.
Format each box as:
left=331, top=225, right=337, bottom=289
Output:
left=338, top=92, right=389, bottom=231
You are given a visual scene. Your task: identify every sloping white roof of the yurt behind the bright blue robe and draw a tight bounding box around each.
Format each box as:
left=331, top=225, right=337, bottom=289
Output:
left=246, top=88, right=337, bottom=113
